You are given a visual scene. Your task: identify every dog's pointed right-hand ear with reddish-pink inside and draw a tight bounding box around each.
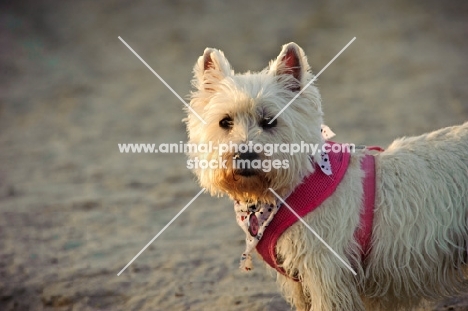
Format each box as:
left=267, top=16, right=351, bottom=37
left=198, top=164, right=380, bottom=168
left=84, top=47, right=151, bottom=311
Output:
left=270, top=42, right=309, bottom=92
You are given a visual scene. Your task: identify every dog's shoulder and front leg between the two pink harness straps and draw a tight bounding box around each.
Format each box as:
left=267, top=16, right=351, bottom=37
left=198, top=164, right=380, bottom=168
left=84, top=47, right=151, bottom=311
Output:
left=276, top=157, right=365, bottom=311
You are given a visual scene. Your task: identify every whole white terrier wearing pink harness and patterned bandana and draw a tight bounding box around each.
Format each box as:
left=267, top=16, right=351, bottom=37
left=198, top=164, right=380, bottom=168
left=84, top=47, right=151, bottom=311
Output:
left=185, top=43, right=468, bottom=311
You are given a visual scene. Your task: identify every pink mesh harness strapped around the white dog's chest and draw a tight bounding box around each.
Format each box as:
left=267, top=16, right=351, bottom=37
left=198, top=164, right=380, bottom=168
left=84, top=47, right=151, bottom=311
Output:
left=256, top=143, right=382, bottom=281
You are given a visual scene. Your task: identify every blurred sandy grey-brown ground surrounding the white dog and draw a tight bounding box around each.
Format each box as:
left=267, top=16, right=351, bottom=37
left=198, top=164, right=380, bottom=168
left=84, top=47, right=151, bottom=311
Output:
left=0, top=0, right=468, bottom=311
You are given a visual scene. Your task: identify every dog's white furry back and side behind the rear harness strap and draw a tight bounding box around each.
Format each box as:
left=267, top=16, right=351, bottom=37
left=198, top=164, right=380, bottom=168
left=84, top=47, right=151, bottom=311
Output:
left=365, top=122, right=468, bottom=310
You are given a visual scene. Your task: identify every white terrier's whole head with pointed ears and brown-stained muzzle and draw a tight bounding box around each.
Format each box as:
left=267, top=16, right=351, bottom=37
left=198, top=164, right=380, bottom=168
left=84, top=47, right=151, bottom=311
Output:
left=185, top=43, right=323, bottom=202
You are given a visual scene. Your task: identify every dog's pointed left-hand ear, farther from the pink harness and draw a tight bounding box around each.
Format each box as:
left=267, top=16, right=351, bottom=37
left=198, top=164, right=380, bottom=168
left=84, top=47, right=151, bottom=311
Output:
left=193, top=48, right=232, bottom=92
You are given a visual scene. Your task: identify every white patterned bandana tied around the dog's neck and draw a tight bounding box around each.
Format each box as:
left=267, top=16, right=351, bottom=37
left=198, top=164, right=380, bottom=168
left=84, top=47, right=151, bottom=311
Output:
left=234, top=124, right=335, bottom=271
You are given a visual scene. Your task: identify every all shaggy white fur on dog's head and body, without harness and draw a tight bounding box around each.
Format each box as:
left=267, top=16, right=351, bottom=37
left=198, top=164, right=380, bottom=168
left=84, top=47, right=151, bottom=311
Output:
left=185, top=43, right=468, bottom=310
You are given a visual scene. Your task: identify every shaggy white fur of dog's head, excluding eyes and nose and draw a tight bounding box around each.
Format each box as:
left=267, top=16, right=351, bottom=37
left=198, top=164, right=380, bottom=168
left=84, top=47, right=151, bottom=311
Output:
left=185, top=43, right=323, bottom=202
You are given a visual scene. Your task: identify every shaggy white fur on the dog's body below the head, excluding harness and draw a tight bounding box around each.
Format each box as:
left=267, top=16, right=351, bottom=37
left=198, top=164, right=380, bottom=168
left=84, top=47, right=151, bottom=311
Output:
left=277, top=123, right=468, bottom=310
